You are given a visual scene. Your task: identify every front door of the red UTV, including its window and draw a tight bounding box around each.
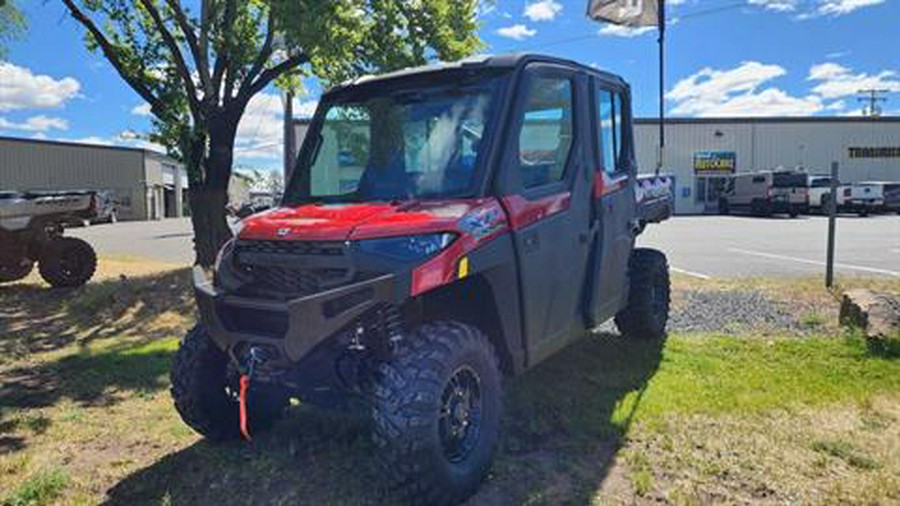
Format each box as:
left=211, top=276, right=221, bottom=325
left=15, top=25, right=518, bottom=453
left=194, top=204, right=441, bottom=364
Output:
left=503, top=64, right=590, bottom=364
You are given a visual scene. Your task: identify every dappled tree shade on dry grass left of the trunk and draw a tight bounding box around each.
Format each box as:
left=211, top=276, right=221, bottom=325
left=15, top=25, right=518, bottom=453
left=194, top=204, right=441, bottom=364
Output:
left=0, top=269, right=194, bottom=363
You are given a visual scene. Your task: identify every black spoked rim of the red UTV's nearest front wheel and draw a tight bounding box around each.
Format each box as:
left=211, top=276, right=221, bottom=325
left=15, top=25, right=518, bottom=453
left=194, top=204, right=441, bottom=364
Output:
left=438, top=366, right=483, bottom=463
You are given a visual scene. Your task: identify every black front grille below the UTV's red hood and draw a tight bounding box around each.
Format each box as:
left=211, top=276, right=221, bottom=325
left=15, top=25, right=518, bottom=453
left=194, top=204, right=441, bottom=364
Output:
left=234, top=241, right=354, bottom=299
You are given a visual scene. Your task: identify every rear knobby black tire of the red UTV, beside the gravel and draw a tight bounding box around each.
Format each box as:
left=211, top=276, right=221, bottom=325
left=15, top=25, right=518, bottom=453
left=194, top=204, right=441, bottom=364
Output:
left=616, top=248, right=671, bottom=340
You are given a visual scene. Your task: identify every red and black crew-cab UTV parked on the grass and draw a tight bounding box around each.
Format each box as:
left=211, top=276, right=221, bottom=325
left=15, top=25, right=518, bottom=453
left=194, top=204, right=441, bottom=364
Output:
left=171, top=55, right=671, bottom=504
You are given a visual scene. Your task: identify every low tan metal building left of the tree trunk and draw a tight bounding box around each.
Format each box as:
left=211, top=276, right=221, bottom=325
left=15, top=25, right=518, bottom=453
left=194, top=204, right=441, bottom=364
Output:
left=0, top=137, right=187, bottom=220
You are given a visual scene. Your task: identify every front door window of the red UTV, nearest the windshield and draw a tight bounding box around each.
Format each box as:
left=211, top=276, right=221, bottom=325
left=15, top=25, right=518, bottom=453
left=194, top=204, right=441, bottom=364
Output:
left=519, top=77, right=573, bottom=188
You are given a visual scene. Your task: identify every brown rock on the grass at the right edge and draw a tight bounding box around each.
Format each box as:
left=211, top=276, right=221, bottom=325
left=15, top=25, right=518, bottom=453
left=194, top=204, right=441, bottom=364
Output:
left=840, top=289, right=900, bottom=356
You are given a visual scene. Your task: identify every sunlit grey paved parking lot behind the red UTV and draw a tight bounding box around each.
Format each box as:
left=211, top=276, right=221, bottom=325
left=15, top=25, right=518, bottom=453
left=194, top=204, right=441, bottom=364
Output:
left=70, top=215, right=900, bottom=278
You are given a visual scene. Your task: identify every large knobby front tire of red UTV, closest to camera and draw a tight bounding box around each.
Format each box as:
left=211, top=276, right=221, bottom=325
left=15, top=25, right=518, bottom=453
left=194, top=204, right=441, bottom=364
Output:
left=372, top=322, right=502, bottom=505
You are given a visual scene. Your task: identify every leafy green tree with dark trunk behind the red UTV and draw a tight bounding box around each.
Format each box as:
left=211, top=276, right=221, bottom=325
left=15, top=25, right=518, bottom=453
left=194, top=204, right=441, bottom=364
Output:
left=62, top=0, right=481, bottom=266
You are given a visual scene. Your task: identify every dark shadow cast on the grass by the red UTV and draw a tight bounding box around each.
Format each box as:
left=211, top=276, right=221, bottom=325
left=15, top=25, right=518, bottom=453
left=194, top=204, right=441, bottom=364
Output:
left=108, top=334, right=662, bottom=505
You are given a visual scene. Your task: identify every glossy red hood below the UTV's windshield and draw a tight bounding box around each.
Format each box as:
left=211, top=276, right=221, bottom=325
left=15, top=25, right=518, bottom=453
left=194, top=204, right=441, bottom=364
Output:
left=239, top=199, right=493, bottom=241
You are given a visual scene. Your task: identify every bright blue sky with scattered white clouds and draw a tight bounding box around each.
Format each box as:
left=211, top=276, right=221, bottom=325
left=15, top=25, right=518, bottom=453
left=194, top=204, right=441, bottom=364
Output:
left=0, top=0, right=900, bottom=168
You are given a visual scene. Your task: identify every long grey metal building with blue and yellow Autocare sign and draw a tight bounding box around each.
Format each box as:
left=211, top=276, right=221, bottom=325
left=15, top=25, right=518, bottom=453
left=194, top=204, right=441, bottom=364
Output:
left=635, top=117, right=900, bottom=214
